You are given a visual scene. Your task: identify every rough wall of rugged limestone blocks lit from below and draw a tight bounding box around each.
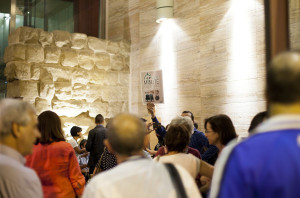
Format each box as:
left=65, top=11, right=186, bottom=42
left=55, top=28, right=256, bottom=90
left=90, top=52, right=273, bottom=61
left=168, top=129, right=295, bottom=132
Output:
left=4, top=27, right=130, bottom=136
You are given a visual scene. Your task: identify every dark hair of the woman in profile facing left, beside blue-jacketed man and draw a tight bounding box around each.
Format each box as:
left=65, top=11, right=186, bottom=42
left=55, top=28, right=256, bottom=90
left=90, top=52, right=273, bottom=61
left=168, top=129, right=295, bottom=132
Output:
left=204, top=114, right=237, bottom=145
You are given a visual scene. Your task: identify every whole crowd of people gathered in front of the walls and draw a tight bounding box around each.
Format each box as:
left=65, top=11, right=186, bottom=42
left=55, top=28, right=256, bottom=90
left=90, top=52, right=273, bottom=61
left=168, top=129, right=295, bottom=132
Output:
left=0, top=52, right=300, bottom=198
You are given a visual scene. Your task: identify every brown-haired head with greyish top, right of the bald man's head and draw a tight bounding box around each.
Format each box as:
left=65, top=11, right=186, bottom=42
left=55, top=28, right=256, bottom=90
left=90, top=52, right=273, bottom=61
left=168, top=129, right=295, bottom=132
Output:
left=165, top=116, right=194, bottom=152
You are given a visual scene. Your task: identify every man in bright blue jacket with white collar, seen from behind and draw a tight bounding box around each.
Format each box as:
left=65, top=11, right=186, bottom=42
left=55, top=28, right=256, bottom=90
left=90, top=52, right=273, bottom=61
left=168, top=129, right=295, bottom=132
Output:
left=211, top=52, right=300, bottom=198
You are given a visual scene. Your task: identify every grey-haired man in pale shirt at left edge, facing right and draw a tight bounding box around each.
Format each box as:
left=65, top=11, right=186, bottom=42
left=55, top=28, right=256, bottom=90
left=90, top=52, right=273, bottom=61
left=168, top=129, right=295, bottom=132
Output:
left=0, top=99, right=43, bottom=198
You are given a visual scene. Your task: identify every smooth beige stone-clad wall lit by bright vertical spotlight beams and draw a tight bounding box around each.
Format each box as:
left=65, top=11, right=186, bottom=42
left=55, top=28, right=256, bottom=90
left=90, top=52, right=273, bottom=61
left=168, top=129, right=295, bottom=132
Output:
left=107, top=0, right=265, bottom=136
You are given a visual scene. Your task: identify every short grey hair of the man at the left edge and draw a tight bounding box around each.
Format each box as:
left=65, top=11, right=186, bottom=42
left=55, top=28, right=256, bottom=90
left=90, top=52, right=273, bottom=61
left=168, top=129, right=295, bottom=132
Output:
left=0, top=98, right=35, bottom=136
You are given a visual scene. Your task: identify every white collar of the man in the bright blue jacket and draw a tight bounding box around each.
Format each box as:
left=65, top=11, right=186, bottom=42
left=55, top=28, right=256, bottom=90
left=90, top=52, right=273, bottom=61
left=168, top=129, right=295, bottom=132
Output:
left=254, top=114, right=300, bottom=133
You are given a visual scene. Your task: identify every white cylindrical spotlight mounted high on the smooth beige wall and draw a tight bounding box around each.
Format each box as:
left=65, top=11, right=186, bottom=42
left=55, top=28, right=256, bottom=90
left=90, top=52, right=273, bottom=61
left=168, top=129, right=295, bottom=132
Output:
left=156, top=0, right=174, bottom=23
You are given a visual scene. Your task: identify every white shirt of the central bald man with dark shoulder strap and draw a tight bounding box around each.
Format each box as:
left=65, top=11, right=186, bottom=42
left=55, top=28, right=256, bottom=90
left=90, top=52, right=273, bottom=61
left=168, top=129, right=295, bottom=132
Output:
left=83, top=155, right=201, bottom=198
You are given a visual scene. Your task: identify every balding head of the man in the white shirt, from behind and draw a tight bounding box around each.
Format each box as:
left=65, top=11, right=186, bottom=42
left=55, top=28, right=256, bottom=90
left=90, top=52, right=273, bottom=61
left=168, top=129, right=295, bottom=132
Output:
left=107, top=114, right=146, bottom=156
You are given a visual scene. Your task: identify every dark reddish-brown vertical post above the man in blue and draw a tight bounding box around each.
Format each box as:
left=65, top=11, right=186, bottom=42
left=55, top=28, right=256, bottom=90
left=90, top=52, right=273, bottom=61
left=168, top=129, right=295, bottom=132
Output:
left=265, top=0, right=289, bottom=63
